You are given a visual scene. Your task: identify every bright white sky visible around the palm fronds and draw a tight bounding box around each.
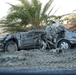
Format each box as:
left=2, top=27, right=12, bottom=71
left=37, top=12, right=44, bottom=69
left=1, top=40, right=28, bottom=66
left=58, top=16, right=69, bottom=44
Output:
left=0, top=0, right=76, bottom=19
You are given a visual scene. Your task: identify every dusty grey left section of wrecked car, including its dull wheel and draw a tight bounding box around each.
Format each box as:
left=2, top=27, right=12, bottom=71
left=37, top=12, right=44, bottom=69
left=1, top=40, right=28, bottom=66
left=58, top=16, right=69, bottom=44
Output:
left=0, top=30, right=55, bottom=52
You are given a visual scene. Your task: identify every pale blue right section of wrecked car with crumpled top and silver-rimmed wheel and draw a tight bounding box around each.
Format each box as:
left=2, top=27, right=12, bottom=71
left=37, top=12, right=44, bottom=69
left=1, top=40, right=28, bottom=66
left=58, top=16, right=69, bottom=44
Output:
left=46, top=20, right=76, bottom=49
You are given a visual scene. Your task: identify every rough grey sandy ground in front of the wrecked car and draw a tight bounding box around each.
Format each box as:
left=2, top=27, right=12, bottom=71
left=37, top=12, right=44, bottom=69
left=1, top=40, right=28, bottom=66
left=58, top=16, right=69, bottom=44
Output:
left=0, top=49, right=76, bottom=71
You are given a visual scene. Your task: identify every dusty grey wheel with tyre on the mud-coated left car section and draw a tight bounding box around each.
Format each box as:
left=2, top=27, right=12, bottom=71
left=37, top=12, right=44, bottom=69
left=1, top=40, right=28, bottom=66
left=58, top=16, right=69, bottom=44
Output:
left=4, top=41, right=18, bottom=52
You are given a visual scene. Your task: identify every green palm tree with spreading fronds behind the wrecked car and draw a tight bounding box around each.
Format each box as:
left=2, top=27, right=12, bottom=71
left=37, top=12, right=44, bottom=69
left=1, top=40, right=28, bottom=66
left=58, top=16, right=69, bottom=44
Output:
left=0, top=0, right=53, bottom=32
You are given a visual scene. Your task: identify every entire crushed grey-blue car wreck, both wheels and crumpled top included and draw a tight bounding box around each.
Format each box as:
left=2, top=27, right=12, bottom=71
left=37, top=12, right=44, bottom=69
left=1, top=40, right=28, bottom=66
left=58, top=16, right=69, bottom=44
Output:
left=0, top=21, right=76, bottom=52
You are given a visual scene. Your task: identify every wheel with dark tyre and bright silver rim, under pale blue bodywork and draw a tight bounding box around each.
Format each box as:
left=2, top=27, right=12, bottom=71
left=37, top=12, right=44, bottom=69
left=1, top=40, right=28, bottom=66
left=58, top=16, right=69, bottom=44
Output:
left=57, top=40, right=71, bottom=49
